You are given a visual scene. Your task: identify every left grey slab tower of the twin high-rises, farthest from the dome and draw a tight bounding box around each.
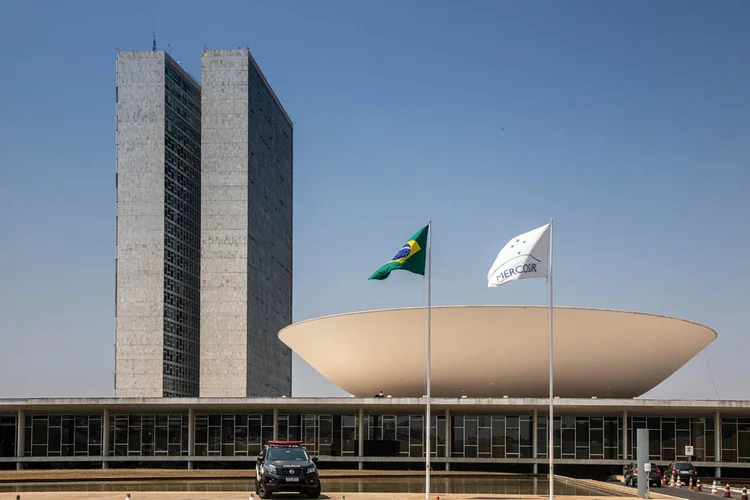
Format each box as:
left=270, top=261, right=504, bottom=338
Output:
left=115, top=51, right=201, bottom=397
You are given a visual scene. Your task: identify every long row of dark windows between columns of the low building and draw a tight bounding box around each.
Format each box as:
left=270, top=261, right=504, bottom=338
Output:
left=5, top=412, right=750, bottom=462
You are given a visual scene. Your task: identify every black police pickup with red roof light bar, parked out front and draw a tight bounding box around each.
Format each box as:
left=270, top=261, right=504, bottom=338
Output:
left=255, top=441, right=320, bottom=498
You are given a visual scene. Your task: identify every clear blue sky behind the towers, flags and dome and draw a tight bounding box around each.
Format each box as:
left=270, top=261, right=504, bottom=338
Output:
left=0, top=0, right=750, bottom=399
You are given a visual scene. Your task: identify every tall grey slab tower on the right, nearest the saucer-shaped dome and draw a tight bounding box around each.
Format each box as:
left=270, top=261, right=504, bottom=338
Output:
left=200, top=50, right=293, bottom=397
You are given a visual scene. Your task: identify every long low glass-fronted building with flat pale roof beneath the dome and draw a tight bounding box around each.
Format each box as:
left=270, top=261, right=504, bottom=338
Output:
left=0, top=397, right=750, bottom=477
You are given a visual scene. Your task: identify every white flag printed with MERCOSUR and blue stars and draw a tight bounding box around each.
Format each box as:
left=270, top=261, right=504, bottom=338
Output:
left=487, top=224, right=549, bottom=287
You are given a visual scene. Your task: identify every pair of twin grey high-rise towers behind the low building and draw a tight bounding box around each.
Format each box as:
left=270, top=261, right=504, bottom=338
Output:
left=115, top=50, right=292, bottom=397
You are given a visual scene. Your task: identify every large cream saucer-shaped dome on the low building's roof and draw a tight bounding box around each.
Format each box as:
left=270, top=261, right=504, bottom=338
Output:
left=279, top=306, right=716, bottom=398
